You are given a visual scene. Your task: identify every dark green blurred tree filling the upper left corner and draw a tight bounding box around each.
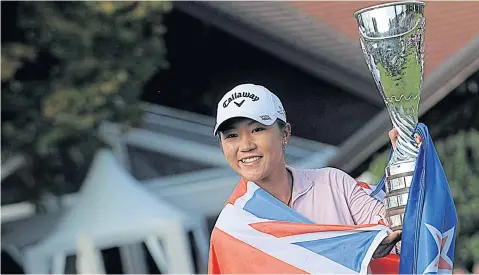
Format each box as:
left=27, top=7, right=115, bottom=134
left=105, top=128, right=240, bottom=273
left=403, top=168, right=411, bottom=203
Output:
left=2, top=1, right=171, bottom=207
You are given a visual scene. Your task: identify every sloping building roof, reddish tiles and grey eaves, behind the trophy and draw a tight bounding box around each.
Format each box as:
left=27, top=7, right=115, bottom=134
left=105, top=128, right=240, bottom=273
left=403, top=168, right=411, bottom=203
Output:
left=174, top=1, right=479, bottom=171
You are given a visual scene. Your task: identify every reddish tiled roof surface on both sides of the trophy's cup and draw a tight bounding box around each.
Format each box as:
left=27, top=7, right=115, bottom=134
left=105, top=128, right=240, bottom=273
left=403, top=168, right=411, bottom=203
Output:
left=289, top=1, right=479, bottom=77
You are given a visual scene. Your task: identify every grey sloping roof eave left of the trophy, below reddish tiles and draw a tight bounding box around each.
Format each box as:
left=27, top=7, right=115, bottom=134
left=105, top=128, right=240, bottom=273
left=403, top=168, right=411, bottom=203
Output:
left=173, top=1, right=383, bottom=107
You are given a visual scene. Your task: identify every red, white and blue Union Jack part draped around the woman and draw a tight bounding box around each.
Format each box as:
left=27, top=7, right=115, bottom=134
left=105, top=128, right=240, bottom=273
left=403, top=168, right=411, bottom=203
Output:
left=209, top=180, right=398, bottom=274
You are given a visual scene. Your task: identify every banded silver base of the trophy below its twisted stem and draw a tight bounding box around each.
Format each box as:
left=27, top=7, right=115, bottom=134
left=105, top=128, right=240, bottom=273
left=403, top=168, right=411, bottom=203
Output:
left=386, top=160, right=416, bottom=230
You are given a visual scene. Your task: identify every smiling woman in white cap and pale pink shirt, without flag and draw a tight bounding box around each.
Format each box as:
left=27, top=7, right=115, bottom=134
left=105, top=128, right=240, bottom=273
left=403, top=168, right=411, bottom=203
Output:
left=214, top=84, right=401, bottom=274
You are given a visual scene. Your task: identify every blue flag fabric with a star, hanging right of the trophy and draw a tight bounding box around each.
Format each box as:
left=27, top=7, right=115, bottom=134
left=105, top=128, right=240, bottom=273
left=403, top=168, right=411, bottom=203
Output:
left=377, top=123, right=457, bottom=274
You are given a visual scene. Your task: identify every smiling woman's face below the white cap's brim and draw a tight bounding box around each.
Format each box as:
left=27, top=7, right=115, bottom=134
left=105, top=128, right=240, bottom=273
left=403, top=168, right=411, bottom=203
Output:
left=220, top=118, right=290, bottom=182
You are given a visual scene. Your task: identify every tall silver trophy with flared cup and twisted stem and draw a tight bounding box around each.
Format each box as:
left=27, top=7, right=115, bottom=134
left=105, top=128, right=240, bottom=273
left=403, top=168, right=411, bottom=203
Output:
left=354, top=1, right=425, bottom=230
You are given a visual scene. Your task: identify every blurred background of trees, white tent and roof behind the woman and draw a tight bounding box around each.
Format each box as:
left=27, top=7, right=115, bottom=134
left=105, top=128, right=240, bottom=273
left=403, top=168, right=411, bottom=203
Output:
left=1, top=1, right=479, bottom=274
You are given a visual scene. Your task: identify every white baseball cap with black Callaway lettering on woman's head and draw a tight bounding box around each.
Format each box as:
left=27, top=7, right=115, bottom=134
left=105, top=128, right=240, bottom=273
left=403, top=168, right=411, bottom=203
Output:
left=213, top=84, right=286, bottom=135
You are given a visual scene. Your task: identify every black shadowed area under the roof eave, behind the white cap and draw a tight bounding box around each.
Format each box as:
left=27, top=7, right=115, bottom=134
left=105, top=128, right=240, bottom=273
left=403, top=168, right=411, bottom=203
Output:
left=142, top=9, right=380, bottom=145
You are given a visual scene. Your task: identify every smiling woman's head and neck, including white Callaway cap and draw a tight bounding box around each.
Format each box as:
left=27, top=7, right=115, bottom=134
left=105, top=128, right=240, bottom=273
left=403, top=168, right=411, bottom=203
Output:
left=214, top=84, right=293, bottom=203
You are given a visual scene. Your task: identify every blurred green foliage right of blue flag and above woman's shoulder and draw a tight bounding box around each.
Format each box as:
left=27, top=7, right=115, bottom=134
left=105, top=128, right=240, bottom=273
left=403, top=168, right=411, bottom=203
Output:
left=369, top=128, right=479, bottom=268
